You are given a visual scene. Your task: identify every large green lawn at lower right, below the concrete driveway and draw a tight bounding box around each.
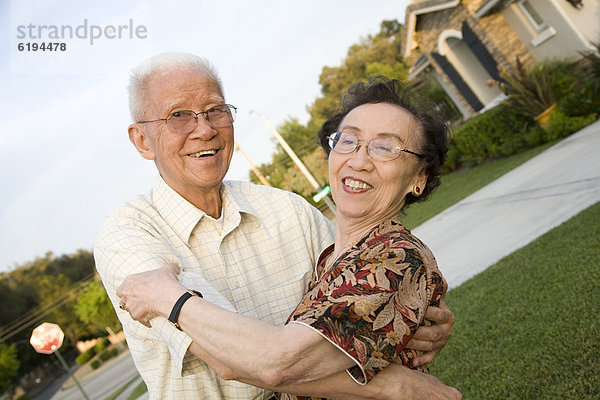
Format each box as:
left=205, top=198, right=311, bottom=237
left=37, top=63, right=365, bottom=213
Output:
left=431, top=203, right=600, bottom=399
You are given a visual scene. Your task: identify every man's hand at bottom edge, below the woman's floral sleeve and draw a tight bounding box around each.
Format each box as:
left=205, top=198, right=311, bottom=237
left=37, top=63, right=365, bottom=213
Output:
left=340, top=362, right=462, bottom=400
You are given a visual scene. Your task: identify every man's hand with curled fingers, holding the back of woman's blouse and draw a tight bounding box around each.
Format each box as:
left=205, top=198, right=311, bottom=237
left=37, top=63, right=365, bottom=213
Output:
left=406, top=298, right=454, bottom=367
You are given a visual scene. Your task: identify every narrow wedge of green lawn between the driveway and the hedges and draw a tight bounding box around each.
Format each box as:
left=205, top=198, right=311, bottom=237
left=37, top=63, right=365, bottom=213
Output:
left=401, top=142, right=556, bottom=229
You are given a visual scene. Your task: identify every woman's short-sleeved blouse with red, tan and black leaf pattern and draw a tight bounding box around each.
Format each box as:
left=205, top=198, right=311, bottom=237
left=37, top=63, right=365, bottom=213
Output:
left=279, top=218, right=445, bottom=400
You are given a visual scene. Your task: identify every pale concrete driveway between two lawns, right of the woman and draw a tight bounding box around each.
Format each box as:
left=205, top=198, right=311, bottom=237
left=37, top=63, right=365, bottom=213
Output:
left=412, top=121, right=600, bottom=288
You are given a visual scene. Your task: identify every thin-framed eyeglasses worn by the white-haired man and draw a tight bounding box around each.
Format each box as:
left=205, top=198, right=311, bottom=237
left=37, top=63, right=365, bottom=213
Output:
left=136, top=104, right=237, bottom=135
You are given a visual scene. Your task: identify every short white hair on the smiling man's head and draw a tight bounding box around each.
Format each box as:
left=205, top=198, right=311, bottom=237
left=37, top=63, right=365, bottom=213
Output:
left=128, top=53, right=223, bottom=122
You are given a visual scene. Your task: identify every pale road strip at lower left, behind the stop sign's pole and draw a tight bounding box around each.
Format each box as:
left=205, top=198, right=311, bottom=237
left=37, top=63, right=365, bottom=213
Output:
left=51, top=351, right=138, bottom=400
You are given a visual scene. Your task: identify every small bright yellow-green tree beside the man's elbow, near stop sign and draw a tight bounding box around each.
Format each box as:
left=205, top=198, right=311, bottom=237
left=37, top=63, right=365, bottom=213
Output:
left=75, top=281, right=121, bottom=331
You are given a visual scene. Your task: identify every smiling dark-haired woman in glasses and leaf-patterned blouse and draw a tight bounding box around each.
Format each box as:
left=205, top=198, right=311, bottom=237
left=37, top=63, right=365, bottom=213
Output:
left=119, top=77, right=459, bottom=399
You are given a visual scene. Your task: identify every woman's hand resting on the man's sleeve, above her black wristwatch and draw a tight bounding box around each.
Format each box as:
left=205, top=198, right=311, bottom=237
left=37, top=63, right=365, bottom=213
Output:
left=117, top=264, right=186, bottom=328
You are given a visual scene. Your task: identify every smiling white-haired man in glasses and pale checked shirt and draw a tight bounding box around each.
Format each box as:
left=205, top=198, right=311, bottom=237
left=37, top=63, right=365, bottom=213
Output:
left=94, top=54, right=456, bottom=399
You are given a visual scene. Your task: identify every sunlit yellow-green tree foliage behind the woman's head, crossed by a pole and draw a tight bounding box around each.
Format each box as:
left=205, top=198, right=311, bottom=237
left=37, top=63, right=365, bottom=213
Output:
left=250, top=20, right=408, bottom=202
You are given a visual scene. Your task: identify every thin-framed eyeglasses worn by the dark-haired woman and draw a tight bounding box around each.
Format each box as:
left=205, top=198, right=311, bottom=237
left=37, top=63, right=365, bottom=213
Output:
left=328, top=132, right=425, bottom=161
